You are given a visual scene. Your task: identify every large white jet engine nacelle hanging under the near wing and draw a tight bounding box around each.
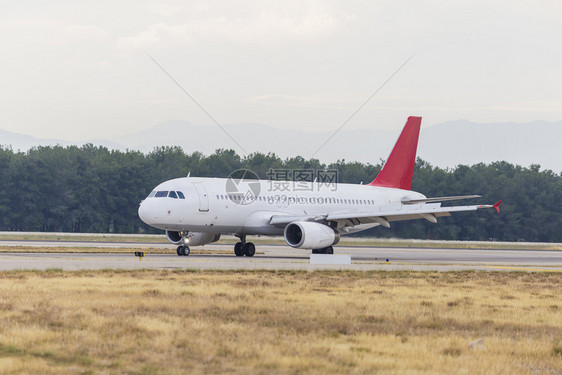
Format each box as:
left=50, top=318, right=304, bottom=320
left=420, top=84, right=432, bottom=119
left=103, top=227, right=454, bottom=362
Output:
left=285, top=221, right=340, bottom=249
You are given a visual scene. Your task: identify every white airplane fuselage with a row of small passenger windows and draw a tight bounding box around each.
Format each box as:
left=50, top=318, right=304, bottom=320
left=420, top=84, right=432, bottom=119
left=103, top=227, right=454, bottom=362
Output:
left=139, top=177, right=425, bottom=235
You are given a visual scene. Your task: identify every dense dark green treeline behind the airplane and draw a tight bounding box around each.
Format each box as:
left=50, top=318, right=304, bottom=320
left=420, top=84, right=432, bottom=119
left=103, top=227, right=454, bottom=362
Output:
left=0, top=145, right=562, bottom=242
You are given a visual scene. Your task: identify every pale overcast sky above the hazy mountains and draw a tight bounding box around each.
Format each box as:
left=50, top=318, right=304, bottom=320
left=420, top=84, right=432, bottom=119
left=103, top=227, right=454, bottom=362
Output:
left=0, top=0, right=562, bottom=147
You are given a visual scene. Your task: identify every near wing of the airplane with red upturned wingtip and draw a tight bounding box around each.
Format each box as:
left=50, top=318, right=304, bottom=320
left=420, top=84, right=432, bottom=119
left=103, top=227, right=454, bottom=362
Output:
left=270, top=201, right=501, bottom=231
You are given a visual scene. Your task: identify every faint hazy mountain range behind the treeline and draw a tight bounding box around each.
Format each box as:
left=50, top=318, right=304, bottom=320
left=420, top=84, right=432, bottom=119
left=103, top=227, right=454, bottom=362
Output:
left=0, top=120, right=562, bottom=173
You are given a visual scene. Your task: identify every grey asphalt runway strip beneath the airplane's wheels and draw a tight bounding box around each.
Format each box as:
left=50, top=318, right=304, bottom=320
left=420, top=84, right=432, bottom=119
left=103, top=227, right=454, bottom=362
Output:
left=0, top=241, right=562, bottom=272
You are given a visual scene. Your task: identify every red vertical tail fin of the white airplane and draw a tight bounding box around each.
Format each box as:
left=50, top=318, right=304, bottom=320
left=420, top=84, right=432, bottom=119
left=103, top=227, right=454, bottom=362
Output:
left=369, top=116, right=421, bottom=190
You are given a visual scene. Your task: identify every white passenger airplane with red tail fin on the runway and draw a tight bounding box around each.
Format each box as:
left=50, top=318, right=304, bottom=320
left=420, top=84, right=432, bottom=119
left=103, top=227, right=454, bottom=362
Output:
left=138, top=116, right=501, bottom=257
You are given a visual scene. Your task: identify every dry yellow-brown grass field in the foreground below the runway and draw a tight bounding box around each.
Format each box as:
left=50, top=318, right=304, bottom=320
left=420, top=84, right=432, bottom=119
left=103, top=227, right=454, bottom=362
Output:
left=0, top=270, right=562, bottom=374
